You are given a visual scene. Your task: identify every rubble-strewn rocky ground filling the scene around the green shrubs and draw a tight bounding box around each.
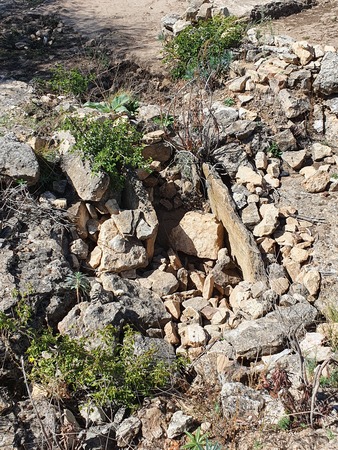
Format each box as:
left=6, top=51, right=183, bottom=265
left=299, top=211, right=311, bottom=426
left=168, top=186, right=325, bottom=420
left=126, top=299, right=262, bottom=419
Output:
left=0, top=1, right=338, bottom=450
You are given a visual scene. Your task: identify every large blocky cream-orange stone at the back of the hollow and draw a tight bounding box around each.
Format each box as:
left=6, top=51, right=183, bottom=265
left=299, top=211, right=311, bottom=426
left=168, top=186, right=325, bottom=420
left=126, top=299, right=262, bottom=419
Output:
left=169, top=211, right=224, bottom=260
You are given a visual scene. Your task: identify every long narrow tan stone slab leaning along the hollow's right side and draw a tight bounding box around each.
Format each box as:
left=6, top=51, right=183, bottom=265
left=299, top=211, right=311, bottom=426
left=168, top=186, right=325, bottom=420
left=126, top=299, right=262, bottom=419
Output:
left=203, top=164, right=266, bottom=282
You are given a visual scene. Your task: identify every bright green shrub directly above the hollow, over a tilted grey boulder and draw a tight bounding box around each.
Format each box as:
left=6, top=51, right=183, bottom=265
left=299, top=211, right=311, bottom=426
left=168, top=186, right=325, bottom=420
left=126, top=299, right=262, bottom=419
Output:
left=64, top=117, right=148, bottom=188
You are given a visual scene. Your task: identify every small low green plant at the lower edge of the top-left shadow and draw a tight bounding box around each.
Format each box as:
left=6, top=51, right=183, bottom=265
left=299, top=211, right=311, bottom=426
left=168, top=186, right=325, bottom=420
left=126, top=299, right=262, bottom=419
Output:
left=48, top=64, right=95, bottom=96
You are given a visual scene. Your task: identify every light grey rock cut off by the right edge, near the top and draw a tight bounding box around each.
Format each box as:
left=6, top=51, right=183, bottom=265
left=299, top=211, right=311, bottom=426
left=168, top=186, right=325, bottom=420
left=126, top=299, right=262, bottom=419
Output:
left=313, top=52, right=338, bottom=95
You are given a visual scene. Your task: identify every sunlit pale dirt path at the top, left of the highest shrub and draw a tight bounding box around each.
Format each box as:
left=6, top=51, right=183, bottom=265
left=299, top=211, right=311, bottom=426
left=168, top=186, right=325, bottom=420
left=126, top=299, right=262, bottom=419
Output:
left=36, top=0, right=188, bottom=69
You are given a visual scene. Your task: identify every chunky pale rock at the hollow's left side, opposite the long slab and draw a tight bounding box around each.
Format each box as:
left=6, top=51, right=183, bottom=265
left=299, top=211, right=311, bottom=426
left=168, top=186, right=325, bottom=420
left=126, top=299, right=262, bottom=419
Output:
left=97, top=219, right=148, bottom=272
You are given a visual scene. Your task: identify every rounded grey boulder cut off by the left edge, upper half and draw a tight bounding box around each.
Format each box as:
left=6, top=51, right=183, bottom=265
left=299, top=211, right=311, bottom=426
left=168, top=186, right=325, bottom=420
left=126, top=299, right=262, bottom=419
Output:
left=0, top=133, right=40, bottom=186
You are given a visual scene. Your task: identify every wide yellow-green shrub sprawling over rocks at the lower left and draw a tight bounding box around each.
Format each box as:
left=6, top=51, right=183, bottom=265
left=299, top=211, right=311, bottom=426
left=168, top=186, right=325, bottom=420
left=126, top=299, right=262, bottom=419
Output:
left=27, top=326, right=174, bottom=409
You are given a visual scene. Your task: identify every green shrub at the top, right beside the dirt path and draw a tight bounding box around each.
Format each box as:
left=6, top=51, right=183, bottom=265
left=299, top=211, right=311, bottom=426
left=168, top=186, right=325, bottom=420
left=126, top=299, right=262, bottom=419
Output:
left=164, top=16, right=243, bottom=79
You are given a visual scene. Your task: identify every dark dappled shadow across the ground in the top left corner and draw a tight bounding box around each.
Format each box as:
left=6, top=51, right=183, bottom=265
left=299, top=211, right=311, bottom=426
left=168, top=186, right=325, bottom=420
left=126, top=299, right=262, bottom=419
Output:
left=0, top=0, right=137, bottom=81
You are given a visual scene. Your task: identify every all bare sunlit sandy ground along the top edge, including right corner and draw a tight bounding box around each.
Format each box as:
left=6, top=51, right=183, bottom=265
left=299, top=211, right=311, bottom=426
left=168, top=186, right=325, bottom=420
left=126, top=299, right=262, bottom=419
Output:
left=34, top=0, right=338, bottom=71
